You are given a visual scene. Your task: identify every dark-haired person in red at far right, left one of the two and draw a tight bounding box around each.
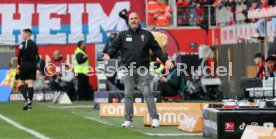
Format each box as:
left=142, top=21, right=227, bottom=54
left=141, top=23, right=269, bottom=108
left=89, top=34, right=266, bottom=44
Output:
left=254, top=53, right=265, bottom=78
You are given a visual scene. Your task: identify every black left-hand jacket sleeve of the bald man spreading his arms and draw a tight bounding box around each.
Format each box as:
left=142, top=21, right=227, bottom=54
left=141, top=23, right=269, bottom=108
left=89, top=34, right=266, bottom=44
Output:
left=107, top=32, right=122, bottom=56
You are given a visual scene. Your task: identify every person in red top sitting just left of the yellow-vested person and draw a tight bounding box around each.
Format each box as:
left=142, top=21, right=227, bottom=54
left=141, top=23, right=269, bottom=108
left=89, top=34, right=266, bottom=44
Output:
left=49, top=50, right=64, bottom=91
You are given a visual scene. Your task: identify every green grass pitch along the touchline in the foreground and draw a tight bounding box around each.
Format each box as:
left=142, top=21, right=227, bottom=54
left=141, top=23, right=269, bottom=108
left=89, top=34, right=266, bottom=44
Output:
left=0, top=102, right=206, bottom=139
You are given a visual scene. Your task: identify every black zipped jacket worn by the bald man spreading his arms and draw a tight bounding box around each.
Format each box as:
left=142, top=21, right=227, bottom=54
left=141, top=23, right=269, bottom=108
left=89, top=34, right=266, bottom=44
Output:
left=107, top=27, right=168, bottom=67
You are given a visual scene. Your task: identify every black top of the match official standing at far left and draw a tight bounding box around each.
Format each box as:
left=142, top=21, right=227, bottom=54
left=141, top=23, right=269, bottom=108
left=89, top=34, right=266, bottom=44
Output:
left=18, top=40, right=38, bottom=65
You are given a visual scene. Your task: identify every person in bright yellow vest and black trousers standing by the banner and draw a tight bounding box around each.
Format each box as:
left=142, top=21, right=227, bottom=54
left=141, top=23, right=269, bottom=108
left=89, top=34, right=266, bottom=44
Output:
left=74, top=40, right=93, bottom=100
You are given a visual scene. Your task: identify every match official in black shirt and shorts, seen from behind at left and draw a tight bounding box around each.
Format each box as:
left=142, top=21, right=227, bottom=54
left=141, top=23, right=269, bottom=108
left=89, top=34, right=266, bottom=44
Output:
left=18, top=29, right=38, bottom=110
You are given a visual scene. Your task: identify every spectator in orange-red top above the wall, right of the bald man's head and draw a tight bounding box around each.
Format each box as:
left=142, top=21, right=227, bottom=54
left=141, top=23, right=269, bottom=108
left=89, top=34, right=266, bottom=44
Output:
left=156, top=0, right=171, bottom=26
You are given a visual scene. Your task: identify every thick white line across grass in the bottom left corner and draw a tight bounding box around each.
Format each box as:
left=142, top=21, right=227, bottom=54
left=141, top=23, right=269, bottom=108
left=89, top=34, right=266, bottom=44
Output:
left=0, top=114, right=50, bottom=139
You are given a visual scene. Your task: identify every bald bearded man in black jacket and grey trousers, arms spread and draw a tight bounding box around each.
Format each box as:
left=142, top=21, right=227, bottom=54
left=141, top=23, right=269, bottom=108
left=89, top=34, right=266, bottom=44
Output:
left=103, top=12, right=173, bottom=127
